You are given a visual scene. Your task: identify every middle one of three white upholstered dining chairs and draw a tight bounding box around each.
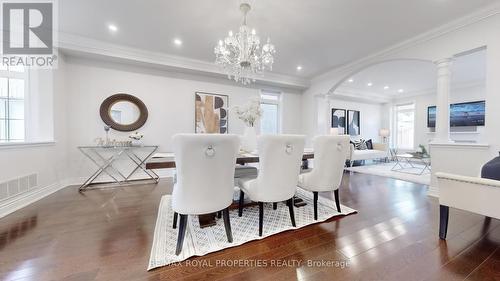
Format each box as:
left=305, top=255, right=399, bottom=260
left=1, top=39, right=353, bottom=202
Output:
left=238, top=135, right=305, bottom=236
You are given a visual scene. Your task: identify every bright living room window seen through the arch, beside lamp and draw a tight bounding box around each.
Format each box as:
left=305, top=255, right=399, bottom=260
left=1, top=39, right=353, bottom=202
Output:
left=395, top=103, right=415, bottom=149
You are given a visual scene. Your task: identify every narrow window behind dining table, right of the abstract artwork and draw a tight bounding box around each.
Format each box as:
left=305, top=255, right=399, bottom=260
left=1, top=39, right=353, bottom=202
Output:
left=260, top=91, right=280, bottom=134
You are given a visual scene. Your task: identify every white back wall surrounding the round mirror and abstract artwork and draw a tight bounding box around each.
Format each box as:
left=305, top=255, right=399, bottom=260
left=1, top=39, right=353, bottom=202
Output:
left=66, top=57, right=302, bottom=178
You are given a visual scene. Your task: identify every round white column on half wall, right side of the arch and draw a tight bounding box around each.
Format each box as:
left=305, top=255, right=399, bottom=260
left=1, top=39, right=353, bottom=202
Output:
left=434, top=58, right=452, bottom=143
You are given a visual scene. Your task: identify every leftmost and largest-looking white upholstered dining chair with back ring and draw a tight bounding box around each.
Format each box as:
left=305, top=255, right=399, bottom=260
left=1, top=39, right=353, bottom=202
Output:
left=172, top=134, right=239, bottom=255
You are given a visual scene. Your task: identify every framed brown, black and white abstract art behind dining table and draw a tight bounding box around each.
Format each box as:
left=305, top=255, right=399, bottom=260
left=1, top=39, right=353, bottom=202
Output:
left=194, top=92, right=229, bottom=134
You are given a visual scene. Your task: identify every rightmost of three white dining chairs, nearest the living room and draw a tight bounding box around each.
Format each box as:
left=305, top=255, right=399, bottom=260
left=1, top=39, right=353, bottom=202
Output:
left=298, top=136, right=350, bottom=220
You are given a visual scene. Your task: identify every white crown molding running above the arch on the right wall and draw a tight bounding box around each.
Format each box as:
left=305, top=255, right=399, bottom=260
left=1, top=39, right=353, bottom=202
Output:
left=311, top=2, right=500, bottom=84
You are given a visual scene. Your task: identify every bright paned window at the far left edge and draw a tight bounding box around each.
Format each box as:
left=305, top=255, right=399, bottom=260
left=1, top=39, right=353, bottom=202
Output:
left=0, top=66, right=26, bottom=143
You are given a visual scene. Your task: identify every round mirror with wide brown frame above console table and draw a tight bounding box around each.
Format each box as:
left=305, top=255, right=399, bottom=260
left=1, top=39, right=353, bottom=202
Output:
left=100, top=93, right=148, bottom=132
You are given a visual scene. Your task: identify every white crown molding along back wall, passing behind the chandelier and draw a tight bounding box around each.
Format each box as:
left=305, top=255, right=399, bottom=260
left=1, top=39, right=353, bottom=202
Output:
left=58, top=32, right=310, bottom=90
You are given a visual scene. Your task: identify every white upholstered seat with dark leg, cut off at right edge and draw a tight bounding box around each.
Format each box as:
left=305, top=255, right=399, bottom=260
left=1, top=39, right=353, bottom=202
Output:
left=436, top=173, right=500, bottom=239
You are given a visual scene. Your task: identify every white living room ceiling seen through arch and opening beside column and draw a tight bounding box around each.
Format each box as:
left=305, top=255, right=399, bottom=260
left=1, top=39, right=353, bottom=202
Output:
left=337, top=50, right=486, bottom=98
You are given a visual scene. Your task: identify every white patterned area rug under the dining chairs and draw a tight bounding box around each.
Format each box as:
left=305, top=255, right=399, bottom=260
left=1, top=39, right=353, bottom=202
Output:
left=148, top=189, right=356, bottom=270
